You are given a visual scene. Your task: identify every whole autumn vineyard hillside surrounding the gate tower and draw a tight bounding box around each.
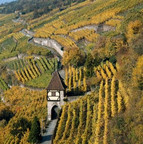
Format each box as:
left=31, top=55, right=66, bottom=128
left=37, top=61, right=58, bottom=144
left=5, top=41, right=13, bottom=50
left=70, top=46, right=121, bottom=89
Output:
left=0, top=0, right=143, bottom=144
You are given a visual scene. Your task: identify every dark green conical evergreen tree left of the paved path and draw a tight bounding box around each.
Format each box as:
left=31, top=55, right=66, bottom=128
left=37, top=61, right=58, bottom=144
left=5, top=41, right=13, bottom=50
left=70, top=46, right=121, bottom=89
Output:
left=28, top=117, right=40, bottom=143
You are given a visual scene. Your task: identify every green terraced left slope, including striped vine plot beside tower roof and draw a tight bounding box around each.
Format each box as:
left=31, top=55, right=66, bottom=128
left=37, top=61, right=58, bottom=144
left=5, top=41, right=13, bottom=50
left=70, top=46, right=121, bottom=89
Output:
left=0, top=14, right=57, bottom=90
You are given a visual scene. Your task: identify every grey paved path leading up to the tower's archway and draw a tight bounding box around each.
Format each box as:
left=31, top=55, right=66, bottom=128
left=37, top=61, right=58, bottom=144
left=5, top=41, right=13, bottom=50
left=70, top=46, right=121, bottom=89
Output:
left=41, top=119, right=58, bottom=144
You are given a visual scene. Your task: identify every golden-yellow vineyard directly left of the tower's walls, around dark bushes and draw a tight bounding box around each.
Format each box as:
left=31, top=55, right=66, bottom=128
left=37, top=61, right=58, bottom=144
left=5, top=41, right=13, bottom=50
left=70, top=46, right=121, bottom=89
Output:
left=0, top=87, right=47, bottom=144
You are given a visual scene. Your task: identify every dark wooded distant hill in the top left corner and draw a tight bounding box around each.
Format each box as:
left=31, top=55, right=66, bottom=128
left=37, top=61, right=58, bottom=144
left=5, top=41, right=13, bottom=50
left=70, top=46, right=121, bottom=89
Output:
left=1, top=0, right=85, bottom=18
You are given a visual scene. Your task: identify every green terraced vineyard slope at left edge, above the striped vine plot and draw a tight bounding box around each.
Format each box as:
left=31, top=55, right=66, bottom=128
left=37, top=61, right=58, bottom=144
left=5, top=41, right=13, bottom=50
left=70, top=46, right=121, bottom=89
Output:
left=0, top=14, right=51, bottom=60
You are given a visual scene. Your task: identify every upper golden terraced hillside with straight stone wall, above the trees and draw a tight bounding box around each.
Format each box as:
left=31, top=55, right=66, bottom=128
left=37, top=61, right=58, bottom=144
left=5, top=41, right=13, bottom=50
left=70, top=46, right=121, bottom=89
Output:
left=20, top=0, right=142, bottom=65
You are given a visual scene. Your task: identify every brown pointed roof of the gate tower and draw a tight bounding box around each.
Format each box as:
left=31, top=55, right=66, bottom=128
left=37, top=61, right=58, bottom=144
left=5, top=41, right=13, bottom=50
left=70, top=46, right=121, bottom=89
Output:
left=47, top=71, right=65, bottom=90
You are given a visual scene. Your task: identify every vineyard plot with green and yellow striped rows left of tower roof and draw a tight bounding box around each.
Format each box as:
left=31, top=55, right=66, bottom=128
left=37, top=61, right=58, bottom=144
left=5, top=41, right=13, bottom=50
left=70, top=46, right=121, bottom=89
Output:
left=12, top=57, right=58, bottom=87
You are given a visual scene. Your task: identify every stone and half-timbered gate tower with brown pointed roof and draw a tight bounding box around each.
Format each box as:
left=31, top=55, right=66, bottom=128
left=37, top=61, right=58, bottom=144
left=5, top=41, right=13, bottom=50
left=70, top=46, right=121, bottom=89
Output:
left=47, top=71, right=65, bottom=120
